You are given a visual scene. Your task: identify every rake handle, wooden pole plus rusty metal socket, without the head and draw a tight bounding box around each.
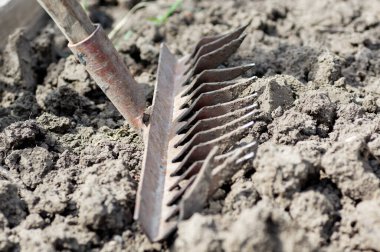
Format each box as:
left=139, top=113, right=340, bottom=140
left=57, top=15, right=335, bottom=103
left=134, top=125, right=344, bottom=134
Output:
left=37, top=0, right=145, bottom=129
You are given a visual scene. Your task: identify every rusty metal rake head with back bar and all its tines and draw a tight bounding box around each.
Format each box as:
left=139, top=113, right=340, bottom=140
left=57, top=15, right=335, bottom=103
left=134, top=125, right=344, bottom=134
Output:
left=135, top=23, right=257, bottom=241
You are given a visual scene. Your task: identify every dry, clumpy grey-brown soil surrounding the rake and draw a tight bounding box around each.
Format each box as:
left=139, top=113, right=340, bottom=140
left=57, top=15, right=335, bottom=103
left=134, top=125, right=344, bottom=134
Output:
left=0, top=0, right=380, bottom=251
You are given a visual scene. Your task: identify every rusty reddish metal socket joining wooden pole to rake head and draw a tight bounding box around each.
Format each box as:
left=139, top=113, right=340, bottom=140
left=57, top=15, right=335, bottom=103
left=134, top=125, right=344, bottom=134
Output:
left=69, top=25, right=145, bottom=129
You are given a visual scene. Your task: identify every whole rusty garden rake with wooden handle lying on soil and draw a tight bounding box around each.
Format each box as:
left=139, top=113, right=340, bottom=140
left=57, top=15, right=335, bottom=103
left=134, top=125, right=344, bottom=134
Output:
left=38, top=0, right=258, bottom=241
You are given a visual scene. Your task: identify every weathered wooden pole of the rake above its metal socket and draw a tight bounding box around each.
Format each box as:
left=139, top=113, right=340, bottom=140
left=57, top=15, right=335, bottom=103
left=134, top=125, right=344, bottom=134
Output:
left=37, top=0, right=95, bottom=44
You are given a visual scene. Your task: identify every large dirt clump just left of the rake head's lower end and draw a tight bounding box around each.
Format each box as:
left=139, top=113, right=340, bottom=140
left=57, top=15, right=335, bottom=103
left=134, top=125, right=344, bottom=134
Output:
left=74, top=160, right=137, bottom=233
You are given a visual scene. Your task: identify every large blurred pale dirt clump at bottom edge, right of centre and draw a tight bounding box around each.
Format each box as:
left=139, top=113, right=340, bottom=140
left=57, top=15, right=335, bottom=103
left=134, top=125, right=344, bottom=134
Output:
left=223, top=201, right=315, bottom=251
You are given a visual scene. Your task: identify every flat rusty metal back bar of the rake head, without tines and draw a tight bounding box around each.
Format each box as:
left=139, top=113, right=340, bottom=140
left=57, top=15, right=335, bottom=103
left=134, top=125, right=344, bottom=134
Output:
left=134, top=45, right=181, bottom=241
